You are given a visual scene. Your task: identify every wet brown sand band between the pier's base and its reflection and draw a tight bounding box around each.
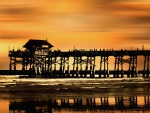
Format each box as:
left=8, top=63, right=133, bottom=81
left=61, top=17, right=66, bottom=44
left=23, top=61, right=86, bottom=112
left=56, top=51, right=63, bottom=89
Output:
left=0, top=76, right=150, bottom=99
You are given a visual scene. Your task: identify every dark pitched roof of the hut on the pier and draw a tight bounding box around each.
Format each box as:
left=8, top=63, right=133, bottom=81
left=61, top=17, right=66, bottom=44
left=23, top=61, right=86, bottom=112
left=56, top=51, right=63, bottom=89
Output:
left=23, top=39, right=54, bottom=48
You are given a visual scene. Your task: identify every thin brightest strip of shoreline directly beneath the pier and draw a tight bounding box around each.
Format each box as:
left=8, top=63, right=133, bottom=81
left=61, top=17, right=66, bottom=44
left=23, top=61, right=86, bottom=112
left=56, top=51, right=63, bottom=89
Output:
left=0, top=75, right=150, bottom=83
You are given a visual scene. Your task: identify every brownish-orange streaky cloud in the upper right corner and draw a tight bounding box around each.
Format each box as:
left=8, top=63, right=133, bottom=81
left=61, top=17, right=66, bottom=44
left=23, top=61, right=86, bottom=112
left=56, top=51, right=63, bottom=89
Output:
left=98, top=2, right=150, bottom=24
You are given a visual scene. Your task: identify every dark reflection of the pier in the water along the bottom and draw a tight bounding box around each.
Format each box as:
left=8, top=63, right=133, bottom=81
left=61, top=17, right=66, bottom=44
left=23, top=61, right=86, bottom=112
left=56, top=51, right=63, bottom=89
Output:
left=9, top=96, right=150, bottom=113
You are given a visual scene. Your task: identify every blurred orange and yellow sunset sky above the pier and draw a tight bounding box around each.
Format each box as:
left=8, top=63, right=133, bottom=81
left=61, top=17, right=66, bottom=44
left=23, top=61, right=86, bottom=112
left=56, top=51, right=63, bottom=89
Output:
left=0, top=0, right=150, bottom=69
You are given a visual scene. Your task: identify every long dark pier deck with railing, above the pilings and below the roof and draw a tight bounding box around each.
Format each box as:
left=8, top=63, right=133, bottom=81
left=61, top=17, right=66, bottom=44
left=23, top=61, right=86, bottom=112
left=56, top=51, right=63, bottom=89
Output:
left=9, top=50, right=150, bottom=57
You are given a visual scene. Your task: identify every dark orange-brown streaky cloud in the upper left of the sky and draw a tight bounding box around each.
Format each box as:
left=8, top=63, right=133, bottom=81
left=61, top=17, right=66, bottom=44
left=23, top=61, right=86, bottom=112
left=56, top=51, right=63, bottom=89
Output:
left=0, top=5, right=43, bottom=22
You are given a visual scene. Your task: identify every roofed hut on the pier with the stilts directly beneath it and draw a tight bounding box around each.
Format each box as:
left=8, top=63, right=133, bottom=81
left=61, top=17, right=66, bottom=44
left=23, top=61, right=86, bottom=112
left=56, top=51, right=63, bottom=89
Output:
left=23, top=39, right=53, bottom=75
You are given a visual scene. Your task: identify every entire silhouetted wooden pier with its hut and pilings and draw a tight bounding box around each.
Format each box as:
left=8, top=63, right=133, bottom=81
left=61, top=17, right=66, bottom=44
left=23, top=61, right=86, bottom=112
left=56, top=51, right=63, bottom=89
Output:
left=6, top=40, right=150, bottom=78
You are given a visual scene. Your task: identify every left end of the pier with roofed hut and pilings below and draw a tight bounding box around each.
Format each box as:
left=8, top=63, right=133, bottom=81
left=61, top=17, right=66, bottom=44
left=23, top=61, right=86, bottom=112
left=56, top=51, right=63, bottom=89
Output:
left=9, top=39, right=53, bottom=74
